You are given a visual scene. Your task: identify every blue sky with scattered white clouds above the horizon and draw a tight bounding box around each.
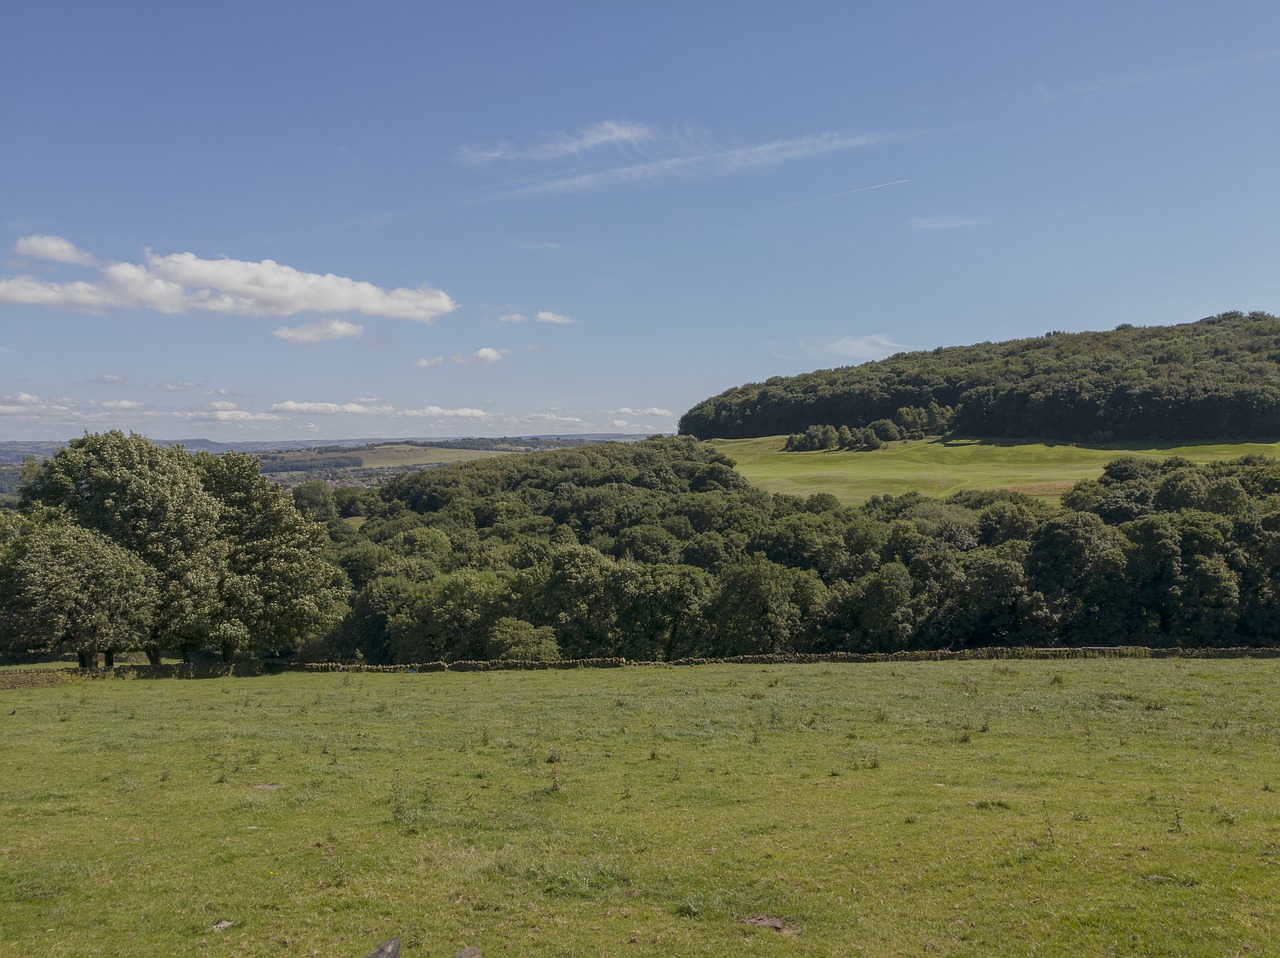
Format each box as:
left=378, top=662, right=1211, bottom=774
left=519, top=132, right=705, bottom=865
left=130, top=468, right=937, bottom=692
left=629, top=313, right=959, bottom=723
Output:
left=0, top=0, right=1280, bottom=441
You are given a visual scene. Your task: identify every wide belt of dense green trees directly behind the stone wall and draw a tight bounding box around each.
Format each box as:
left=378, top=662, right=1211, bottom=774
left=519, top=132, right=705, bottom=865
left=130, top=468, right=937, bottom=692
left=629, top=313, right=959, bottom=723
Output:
left=0, top=433, right=1280, bottom=663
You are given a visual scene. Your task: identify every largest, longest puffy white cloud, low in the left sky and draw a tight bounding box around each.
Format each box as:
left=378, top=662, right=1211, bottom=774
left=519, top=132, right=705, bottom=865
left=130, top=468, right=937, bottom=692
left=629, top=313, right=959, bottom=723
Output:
left=0, top=237, right=456, bottom=323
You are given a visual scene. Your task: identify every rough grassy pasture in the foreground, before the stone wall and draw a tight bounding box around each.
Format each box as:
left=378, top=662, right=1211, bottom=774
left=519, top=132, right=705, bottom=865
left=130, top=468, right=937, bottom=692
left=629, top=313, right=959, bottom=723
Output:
left=0, top=660, right=1280, bottom=958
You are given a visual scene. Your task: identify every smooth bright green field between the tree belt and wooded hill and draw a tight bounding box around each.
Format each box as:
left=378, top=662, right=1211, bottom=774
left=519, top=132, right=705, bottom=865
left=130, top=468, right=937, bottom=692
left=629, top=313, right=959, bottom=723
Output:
left=712, top=435, right=1280, bottom=505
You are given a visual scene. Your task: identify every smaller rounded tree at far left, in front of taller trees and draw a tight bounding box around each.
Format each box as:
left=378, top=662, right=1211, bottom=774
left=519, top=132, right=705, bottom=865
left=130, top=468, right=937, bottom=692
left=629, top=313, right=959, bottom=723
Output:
left=0, top=519, right=160, bottom=669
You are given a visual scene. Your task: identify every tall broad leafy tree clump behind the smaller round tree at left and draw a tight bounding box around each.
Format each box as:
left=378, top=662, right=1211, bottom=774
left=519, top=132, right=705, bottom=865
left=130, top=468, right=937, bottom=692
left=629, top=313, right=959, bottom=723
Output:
left=13, top=432, right=344, bottom=661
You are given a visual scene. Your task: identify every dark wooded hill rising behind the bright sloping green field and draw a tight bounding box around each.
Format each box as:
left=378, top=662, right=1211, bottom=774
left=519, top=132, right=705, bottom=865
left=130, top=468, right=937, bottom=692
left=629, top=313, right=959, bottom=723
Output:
left=680, top=313, right=1280, bottom=442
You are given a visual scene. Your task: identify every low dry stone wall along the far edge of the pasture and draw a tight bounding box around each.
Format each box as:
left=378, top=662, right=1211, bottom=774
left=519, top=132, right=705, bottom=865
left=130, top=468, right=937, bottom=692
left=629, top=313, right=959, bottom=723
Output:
left=0, top=645, right=1280, bottom=689
